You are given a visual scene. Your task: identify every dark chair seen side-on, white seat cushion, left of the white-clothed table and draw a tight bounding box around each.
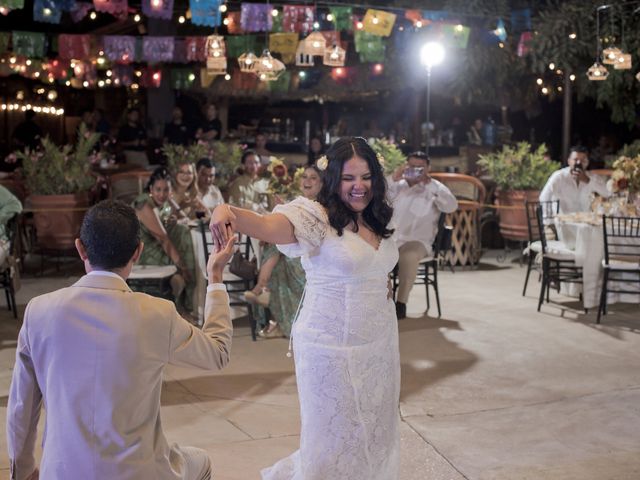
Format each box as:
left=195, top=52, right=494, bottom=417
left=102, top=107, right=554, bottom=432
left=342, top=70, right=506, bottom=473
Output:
left=536, top=205, right=582, bottom=311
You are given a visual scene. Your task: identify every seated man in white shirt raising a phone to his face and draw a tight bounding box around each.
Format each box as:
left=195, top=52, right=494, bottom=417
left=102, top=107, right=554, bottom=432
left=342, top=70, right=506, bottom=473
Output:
left=387, top=152, right=458, bottom=319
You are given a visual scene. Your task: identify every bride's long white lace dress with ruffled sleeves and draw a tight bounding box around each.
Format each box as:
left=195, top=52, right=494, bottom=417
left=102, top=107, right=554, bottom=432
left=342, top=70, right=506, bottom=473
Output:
left=262, top=197, right=400, bottom=480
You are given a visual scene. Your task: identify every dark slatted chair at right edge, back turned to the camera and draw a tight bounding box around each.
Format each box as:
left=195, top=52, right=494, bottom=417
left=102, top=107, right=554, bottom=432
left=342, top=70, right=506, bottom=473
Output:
left=596, top=215, right=640, bottom=323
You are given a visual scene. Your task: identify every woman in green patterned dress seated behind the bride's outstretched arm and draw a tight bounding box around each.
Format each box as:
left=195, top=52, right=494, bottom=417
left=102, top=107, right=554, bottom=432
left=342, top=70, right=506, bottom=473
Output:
left=245, top=165, right=322, bottom=338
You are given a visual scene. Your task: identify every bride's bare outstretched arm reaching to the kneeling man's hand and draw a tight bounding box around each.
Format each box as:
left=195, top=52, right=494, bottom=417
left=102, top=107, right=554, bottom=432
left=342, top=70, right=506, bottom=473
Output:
left=209, top=203, right=296, bottom=249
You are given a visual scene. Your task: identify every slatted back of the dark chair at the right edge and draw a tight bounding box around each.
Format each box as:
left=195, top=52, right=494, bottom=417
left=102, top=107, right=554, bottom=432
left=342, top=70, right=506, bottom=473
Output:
left=602, top=215, right=640, bottom=265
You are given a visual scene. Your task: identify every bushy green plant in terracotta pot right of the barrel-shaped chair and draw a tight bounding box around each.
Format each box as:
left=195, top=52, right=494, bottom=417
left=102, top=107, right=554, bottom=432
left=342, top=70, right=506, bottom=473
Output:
left=478, top=142, right=560, bottom=240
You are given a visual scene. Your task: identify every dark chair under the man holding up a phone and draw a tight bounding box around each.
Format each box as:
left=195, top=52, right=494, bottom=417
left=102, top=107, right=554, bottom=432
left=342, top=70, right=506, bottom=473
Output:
left=391, top=213, right=453, bottom=318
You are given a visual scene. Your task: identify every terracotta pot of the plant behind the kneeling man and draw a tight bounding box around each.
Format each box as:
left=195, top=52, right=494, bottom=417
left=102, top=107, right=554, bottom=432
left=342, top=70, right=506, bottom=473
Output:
left=29, top=192, right=89, bottom=250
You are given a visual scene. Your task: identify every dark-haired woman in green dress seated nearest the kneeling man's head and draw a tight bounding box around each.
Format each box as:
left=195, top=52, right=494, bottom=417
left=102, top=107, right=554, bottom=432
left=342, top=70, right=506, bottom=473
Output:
left=133, top=167, right=196, bottom=315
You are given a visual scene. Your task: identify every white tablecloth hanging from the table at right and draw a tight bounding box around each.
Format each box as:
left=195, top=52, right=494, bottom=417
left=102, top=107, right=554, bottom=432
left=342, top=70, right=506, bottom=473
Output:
left=555, top=221, right=640, bottom=308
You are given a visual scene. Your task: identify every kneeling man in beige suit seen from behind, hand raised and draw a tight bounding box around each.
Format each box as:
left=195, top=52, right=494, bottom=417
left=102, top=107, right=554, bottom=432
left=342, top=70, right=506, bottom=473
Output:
left=7, top=201, right=238, bottom=480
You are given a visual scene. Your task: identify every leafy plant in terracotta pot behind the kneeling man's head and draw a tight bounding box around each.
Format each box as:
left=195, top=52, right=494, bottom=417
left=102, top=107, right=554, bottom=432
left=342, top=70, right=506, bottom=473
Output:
left=16, top=124, right=100, bottom=250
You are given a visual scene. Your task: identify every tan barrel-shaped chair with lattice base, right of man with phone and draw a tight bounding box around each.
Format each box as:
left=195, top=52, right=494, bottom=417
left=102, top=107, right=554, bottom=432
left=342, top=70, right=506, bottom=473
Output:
left=431, top=173, right=487, bottom=265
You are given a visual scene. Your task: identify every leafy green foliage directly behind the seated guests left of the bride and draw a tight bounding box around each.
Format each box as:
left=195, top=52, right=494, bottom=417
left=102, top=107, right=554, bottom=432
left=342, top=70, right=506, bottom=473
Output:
left=162, top=141, right=242, bottom=188
